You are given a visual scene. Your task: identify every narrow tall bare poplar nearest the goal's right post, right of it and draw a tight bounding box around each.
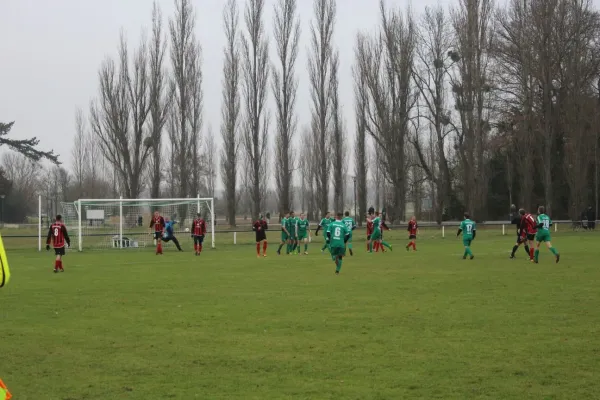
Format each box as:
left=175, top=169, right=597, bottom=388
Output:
left=221, top=0, right=240, bottom=226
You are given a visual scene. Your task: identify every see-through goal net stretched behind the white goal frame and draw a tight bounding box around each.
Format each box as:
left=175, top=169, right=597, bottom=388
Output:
left=56, top=198, right=215, bottom=251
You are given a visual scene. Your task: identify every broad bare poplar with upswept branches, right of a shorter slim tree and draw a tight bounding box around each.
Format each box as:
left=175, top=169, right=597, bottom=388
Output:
left=357, top=1, right=417, bottom=220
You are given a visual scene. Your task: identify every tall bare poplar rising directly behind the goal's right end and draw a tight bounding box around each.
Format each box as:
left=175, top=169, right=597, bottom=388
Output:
left=168, top=0, right=202, bottom=197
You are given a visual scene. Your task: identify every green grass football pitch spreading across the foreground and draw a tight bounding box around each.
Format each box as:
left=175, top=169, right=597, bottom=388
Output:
left=0, top=228, right=600, bottom=400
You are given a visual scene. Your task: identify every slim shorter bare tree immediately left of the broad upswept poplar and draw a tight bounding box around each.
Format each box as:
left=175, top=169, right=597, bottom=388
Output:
left=352, top=50, right=369, bottom=226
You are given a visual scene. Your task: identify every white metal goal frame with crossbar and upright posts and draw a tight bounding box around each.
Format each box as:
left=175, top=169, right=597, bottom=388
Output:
left=72, top=196, right=215, bottom=251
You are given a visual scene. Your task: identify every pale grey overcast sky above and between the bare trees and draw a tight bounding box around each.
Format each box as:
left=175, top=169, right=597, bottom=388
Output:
left=0, top=0, right=520, bottom=173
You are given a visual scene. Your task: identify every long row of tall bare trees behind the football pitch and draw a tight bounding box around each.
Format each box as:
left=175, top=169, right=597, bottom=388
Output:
left=4, top=0, right=600, bottom=224
